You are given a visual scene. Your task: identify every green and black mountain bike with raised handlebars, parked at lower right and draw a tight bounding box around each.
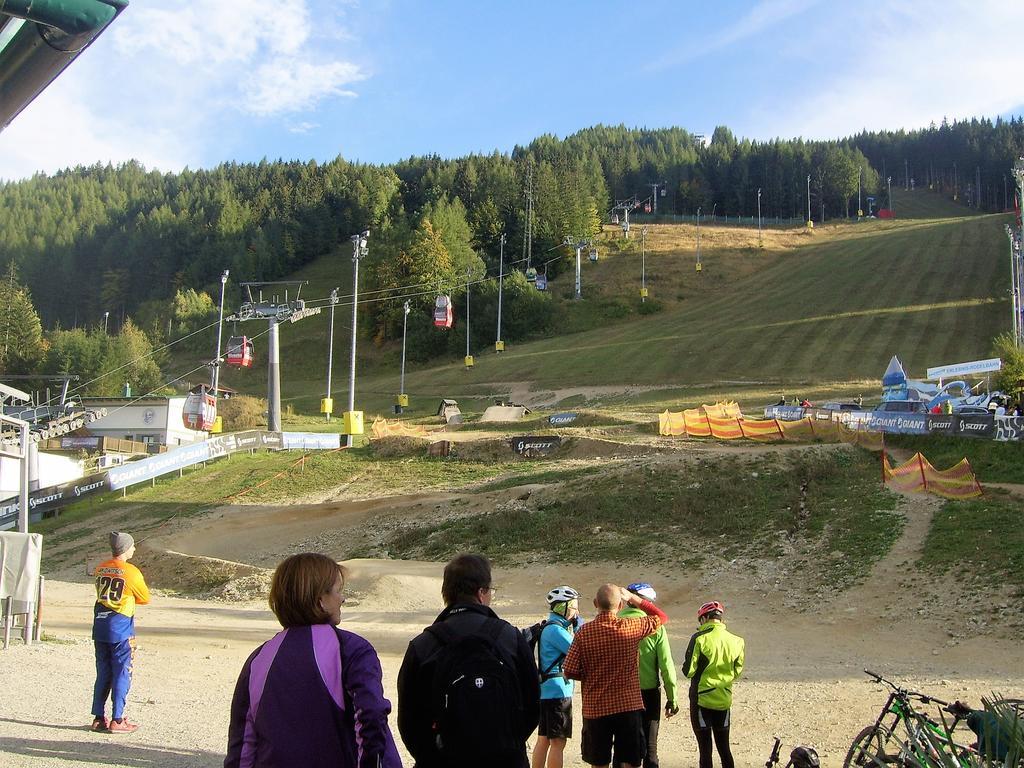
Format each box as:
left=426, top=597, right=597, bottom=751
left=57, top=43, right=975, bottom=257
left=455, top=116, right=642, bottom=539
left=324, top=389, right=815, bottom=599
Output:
left=843, top=670, right=977, bottom=768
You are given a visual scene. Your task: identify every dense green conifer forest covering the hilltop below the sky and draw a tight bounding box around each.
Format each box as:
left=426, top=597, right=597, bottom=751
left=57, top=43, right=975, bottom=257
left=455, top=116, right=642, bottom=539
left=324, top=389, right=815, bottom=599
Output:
left=0, top=118, right=1024, bottom=393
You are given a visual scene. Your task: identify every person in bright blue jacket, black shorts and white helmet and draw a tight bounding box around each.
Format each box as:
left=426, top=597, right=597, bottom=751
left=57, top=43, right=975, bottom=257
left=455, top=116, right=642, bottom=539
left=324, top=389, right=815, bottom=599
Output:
left=530, top=586, right=582, bottom=768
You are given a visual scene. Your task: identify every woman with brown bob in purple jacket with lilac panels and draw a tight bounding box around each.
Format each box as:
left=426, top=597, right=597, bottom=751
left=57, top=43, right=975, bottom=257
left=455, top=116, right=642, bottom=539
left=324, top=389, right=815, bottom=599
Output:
left=224, top=552, right=401, bottom=768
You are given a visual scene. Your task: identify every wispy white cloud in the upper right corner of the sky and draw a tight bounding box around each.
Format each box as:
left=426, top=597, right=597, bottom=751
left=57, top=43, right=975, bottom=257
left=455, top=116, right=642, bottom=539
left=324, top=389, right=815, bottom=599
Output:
left=746, top=0, right=1024, bottom=138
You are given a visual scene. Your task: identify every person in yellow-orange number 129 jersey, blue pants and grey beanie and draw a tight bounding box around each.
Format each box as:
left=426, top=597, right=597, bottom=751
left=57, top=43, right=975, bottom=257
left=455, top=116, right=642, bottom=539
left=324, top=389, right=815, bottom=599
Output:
left=92, top=531, right=150, bottom=733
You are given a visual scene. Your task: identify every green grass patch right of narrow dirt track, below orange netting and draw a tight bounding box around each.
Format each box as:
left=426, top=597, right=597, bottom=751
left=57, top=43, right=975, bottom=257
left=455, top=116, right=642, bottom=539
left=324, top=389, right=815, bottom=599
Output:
left=921, top=490, right=1024, bottom=594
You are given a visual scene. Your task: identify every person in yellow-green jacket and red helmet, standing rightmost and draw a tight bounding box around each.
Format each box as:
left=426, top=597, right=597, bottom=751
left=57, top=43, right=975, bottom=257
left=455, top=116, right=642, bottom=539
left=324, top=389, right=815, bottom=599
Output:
left=683, top=600, right=743, bottom=768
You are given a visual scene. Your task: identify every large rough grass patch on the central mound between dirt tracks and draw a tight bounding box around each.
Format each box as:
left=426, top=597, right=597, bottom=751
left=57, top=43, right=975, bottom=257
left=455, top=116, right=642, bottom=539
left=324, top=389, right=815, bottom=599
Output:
left=387, top=451, right=899, bottom=586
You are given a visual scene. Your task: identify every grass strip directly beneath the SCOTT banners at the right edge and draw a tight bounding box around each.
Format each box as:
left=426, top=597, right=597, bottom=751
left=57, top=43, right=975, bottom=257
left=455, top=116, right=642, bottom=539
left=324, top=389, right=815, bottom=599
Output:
left=886, top=435, right=1024, bottom=484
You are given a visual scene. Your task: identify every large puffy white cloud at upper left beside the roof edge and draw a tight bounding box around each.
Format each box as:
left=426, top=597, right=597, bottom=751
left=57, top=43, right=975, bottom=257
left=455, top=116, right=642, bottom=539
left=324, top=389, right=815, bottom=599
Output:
left=0, top=0, right=367, bottom=179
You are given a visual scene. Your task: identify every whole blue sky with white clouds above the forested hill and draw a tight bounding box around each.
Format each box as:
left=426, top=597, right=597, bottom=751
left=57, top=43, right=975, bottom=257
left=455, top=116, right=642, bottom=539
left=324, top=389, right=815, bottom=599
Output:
left=0, top=0, right=1024, bottom=179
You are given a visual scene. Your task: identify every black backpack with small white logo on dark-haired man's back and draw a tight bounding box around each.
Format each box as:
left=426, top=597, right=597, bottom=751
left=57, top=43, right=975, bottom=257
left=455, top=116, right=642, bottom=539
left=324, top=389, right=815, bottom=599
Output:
left=426, top=618, right=525, bottom=766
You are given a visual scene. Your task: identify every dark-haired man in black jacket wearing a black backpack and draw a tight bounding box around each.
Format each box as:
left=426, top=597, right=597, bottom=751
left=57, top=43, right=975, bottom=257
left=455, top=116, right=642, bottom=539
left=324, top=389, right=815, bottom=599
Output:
left=398, top=554, right=541, bottom=768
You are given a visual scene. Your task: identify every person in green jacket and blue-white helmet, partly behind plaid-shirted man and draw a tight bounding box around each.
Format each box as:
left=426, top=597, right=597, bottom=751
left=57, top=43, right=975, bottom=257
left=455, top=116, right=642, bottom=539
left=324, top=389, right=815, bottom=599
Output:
left=612, top=582, right=679, bottom=768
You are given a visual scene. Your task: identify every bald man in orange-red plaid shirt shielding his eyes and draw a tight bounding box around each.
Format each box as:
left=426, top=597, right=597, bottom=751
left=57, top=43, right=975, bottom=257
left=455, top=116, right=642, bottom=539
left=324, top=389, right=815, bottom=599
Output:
left=562, top=584, right=669, bottom=768
